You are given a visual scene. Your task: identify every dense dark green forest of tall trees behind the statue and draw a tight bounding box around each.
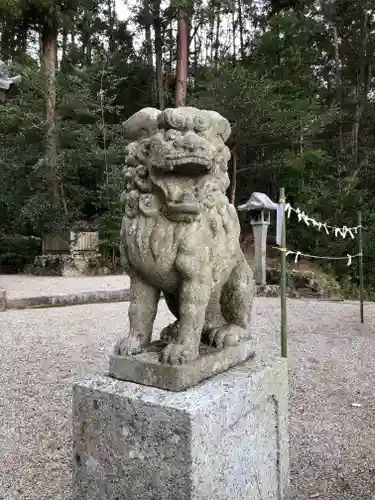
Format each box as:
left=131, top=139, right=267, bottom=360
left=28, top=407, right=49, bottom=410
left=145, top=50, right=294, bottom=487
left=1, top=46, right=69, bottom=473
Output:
left=0, top=0, right=375, bottom=292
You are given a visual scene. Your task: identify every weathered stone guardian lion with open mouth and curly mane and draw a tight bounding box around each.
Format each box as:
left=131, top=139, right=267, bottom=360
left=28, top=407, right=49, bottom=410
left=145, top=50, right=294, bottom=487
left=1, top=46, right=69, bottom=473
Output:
left=115, top=107, right=254, bottom=364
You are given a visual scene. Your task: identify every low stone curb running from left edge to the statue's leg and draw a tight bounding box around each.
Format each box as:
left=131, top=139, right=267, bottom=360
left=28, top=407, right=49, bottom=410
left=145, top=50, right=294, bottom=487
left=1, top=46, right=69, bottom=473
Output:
left=0, top=289, right=130, bottom=311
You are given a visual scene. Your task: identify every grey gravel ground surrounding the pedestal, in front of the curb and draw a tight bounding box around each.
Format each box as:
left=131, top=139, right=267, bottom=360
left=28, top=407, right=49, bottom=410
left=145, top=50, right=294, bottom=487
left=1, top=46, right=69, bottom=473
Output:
left=0, top=298, right=375, bottom=500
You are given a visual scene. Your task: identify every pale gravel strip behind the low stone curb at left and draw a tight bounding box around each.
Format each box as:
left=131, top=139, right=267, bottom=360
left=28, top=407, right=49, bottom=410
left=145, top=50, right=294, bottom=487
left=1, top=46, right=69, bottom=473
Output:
left=0, top=274, right=129, bottom=299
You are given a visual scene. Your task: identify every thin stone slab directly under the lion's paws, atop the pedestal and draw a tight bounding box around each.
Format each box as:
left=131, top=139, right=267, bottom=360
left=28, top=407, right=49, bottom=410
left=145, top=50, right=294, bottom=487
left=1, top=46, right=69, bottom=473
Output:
left=109, top=340, right=255, bottom=392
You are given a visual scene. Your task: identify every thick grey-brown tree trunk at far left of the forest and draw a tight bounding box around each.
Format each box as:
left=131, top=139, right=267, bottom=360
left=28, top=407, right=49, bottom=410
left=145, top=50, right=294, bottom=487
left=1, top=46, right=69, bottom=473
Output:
left=41, top=25, right=60, bottom=205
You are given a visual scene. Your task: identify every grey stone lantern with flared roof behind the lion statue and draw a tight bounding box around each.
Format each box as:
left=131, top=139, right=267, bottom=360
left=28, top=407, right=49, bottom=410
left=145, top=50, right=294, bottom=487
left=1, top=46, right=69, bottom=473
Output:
left=237, top=193, right=277, bottom=286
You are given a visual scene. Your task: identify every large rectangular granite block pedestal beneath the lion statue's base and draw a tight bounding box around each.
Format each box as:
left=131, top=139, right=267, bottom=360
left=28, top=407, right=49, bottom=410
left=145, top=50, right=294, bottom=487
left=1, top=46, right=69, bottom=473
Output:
left=73, top=359, right=288, bottom=500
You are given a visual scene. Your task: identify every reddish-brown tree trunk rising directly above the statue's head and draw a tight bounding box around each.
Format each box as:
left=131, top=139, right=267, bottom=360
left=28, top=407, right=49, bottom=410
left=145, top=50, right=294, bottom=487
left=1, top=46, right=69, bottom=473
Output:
left=175, top=9, right=189, bottom=108
